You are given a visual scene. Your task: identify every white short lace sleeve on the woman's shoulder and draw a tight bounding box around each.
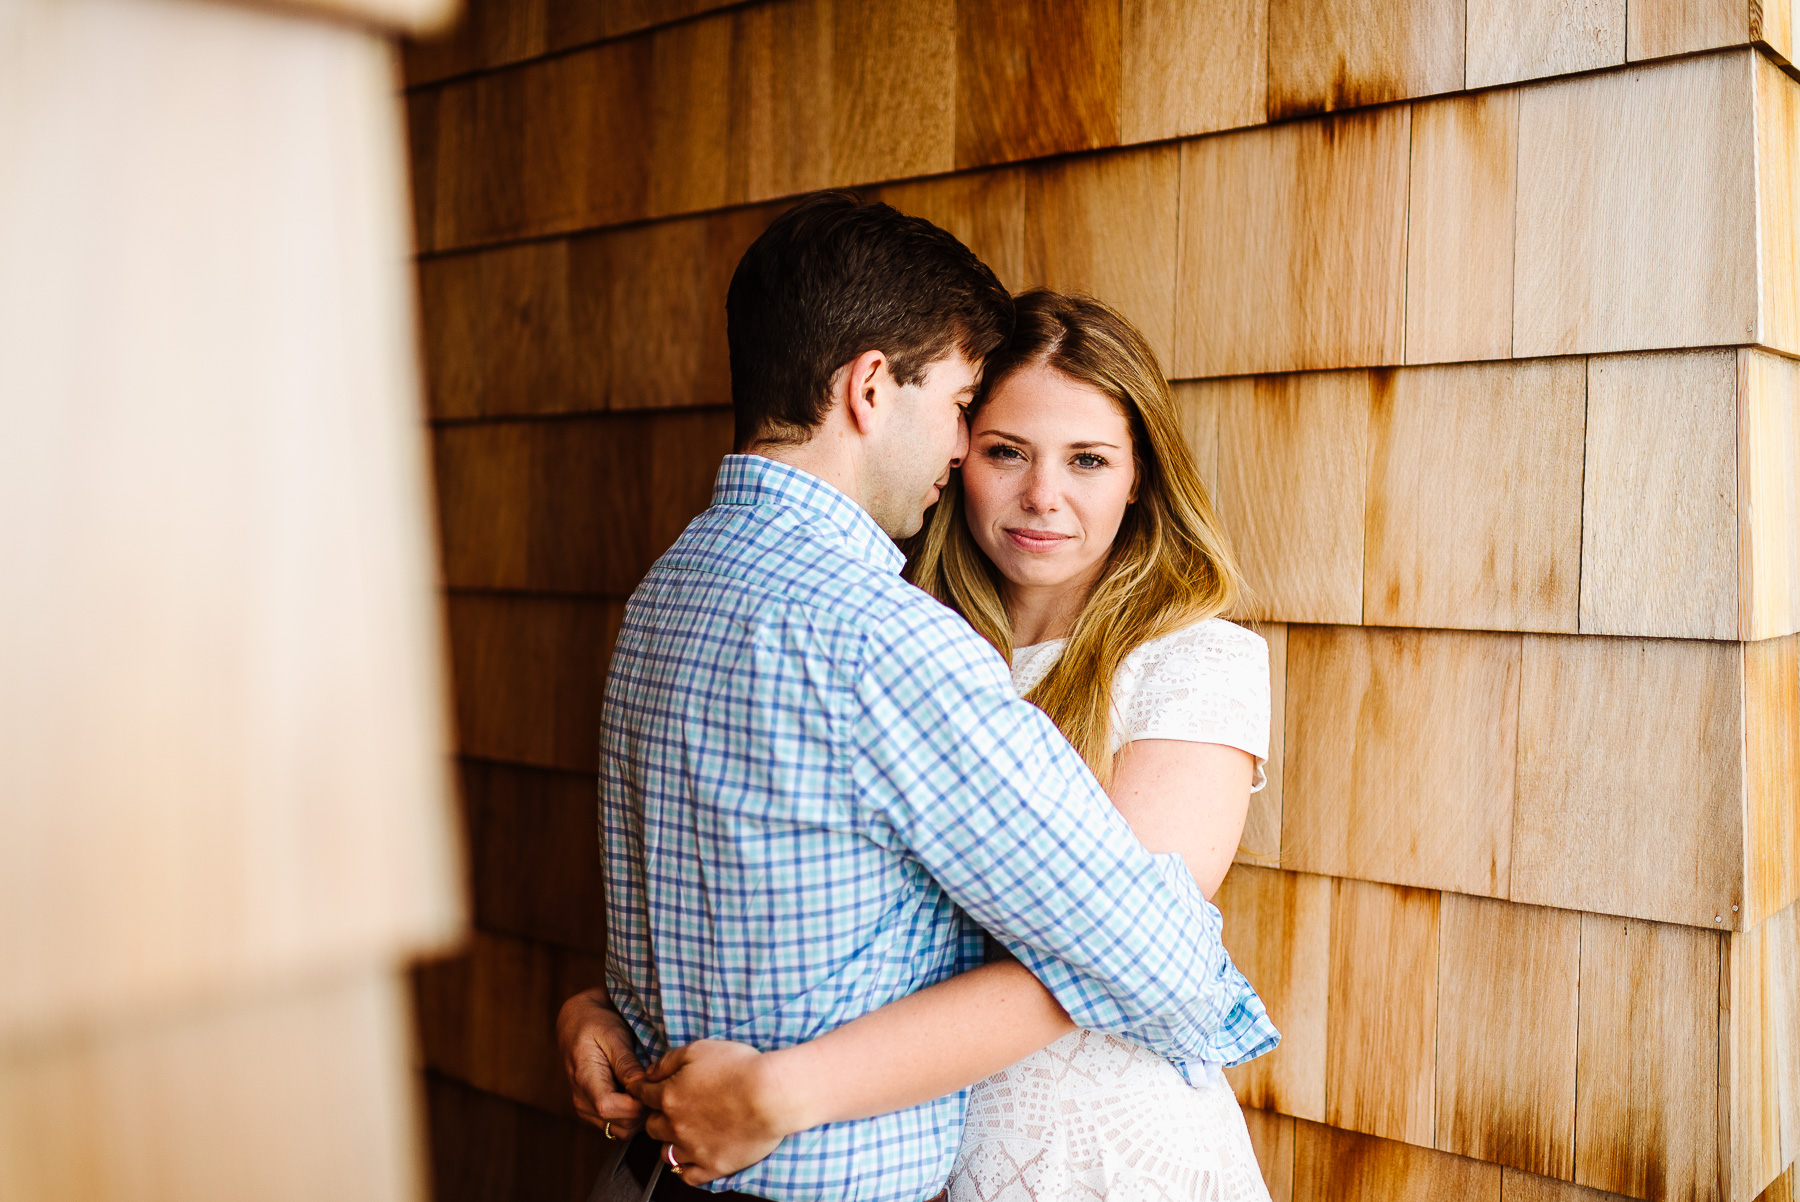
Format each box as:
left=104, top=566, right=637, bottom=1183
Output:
left=1118, top=619, right=1269, bottom=792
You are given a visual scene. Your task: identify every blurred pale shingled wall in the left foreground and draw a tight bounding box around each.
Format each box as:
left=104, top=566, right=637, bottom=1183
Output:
left=0, top=0, right=463, bottom=1202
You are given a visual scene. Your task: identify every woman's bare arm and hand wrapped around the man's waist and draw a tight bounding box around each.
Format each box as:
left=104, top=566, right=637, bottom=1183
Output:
left=632, top=740, right=1255, bottom=1184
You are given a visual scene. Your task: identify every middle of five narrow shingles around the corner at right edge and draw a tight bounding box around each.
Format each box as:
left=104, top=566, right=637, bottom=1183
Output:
left=1737, top=351, right=1800, bottom=639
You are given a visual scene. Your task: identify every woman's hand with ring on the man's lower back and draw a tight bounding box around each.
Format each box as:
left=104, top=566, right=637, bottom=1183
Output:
left=628, top=1040, right=810, bottom=1186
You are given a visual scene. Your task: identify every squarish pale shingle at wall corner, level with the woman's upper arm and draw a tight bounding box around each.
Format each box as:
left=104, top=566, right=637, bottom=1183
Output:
left=1512, top=635, right=1742, bottom=928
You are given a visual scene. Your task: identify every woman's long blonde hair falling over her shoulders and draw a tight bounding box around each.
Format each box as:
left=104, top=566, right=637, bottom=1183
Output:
left=905, top=288, right=1244, bottom=783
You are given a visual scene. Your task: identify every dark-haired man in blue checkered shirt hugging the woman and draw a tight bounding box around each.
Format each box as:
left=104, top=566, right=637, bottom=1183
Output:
left=558, top=193, right=1274, bottom=1202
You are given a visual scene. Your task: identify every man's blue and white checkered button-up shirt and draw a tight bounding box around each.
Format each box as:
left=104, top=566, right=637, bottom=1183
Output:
left=601, top=455, right=1278, bottom=1202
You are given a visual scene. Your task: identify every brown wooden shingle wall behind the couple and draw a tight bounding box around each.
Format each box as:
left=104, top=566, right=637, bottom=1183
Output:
left=407, top=0, right=1800, bottom=1202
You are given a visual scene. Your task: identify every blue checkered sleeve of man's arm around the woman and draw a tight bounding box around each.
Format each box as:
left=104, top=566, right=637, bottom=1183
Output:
left=853, top=596, right=1278, bottom=1063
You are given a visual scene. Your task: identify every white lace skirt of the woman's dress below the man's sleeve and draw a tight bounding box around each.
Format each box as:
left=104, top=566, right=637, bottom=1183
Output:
left=949, top=1031, right=1269, bottom=1202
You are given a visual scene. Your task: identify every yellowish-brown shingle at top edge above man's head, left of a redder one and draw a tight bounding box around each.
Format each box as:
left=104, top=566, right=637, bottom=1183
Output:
left=832, top=0, right=956, bottom=184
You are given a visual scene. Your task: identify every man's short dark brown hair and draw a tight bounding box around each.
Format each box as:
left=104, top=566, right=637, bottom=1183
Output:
left=725, top=191, right=1012, bottom=450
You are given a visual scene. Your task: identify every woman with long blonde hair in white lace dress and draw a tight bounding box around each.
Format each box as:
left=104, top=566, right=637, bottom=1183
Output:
left=626, top=290, right=1269, bottom=1202
